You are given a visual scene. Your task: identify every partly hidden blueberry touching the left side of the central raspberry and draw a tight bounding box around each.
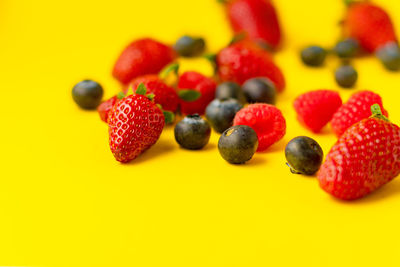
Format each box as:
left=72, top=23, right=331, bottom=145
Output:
left=206, top=98, right=243, bottom=133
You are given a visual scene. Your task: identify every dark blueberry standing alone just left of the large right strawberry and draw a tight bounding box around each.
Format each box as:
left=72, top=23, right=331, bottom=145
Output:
left=285, top=136, right=324, bottom=175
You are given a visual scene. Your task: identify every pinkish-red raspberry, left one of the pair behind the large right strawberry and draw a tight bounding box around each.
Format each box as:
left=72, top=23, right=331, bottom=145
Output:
left=293, top=90, right=342, bottom=133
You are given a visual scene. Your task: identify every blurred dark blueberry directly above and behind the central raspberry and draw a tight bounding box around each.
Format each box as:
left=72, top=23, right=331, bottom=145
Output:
left=243, top=78, right=276, bottom=105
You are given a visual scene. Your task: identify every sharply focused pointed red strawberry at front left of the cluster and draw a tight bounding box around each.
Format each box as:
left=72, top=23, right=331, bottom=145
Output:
left=108, top=95, right=164, bottom=163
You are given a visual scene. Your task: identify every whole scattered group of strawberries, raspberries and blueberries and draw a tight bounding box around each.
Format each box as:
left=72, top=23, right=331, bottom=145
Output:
left=72, top=0, right=400, bottom=200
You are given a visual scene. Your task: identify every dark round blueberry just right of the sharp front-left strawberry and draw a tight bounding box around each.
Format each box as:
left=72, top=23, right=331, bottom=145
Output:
left=175, top=114, right=211, bottom=150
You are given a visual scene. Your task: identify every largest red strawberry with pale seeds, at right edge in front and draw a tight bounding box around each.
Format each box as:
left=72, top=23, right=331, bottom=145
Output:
left=318, top=105, right=400, bottom=200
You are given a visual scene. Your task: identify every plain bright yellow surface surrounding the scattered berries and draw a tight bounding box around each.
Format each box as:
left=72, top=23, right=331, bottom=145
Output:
left=0, top=0, right=400, bottom=267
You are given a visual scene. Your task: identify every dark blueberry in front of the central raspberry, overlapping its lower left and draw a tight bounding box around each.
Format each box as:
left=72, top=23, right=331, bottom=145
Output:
left=218, top=125, right=258, bottom=164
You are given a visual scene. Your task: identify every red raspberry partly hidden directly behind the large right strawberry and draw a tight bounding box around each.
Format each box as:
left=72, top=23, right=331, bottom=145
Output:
left=331, top=91, right=388, bottom=136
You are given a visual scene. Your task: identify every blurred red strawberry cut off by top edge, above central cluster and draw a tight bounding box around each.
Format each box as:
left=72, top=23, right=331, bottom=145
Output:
left=226, top=0, right=281, bottom=48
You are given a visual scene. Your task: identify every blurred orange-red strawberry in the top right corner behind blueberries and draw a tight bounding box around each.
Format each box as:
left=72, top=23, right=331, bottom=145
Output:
left=343, top=2, right=397, bottom=52
